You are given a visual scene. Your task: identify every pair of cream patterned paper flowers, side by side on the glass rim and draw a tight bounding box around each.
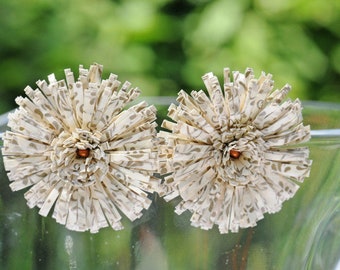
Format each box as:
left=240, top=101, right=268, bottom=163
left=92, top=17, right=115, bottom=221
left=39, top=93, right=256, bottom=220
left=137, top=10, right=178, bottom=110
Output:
left=2, top=64, right=311, bottom=233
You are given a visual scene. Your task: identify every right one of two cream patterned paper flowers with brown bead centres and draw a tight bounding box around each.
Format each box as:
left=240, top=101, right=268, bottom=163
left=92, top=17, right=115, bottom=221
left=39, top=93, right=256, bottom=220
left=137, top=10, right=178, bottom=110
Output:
left=159, top=69, right=311, bottom=233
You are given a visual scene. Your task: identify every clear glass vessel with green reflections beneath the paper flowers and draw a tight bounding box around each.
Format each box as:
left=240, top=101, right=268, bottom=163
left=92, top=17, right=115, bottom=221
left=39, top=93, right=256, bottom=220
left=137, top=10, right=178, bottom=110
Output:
left=0, top=99, right=340, bottom=270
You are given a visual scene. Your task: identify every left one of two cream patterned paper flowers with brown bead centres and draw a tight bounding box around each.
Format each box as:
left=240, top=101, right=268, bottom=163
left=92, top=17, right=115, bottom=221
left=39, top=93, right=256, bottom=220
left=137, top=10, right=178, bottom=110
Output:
left=2, top=64, right=159, bottom=232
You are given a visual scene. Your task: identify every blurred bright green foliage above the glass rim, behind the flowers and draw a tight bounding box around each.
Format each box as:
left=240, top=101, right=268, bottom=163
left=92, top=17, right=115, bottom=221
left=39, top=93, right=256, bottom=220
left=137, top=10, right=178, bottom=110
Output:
left=0, top=0, right=340, bottom=113
